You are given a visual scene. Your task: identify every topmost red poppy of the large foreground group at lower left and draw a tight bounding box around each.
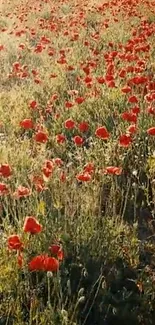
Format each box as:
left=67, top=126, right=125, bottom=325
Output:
left=23, top=216, right=42, bottom=234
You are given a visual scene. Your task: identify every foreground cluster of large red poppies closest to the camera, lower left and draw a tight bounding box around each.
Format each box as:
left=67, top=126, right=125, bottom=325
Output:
left=7, top=216, right=64, bottom=272
